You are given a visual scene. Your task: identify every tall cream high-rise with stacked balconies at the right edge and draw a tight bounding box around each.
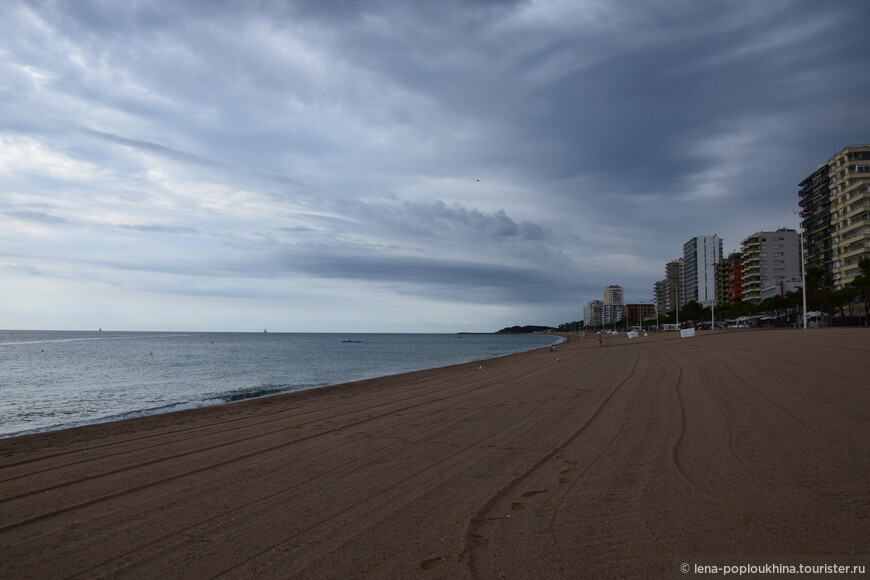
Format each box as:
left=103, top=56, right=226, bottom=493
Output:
left=828, top=144, right=870, bottom=290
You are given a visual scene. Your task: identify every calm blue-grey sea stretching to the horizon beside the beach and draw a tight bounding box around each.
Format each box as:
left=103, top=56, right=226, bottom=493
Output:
left=0, top=330, right=560, bottom=438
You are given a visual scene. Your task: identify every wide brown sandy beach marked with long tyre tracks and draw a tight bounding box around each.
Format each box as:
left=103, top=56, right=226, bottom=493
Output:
left=0, top=329, right=870, bottom=579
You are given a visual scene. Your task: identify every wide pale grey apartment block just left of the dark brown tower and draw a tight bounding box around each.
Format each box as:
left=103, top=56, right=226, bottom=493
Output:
left=741, top=228, right=801, bottom=304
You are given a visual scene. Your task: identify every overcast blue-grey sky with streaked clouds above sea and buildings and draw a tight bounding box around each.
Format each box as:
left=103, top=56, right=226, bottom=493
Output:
left=0, top=0, right=870, bottom=332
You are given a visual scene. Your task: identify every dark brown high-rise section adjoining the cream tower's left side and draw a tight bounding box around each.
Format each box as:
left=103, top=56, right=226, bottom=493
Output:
left=799, top=163, right=834, bottom=284
